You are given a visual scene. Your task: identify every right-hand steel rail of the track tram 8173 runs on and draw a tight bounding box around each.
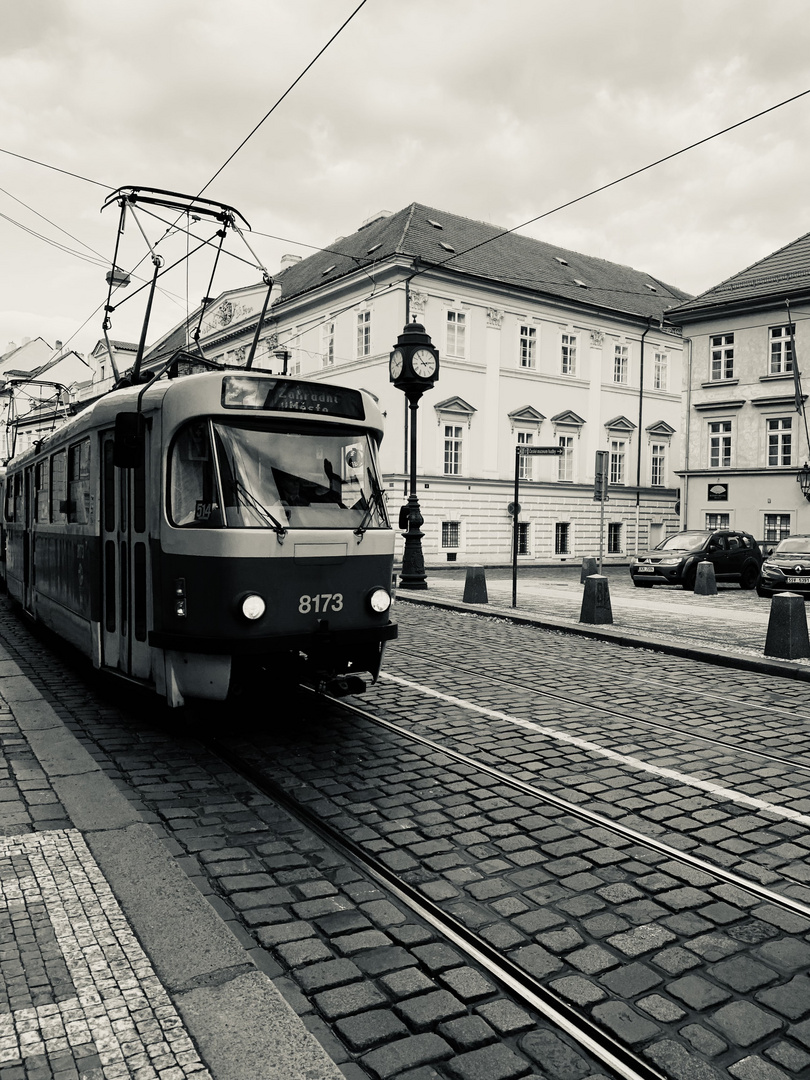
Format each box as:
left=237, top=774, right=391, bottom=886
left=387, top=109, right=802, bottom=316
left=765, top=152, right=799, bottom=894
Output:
left=327, top=698, right=810, bottom=919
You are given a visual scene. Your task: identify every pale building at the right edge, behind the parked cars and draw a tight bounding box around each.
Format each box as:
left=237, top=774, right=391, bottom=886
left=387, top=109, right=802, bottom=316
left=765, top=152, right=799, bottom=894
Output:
left=670, top=234, right=810, bottom=544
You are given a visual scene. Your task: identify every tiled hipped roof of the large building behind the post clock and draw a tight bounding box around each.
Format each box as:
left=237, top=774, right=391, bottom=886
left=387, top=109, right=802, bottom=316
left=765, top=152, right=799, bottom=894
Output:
left=276, top=203, right=689, bottom=319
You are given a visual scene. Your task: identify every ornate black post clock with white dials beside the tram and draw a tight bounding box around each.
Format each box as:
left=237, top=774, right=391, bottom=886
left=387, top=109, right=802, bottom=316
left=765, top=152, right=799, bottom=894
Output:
left=388, top=323, right=438, bottom=589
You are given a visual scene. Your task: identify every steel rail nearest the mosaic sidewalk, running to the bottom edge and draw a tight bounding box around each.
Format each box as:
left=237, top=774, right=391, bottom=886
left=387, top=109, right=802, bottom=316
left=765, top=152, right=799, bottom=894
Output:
left=207, top=734, right=666, bottom=1080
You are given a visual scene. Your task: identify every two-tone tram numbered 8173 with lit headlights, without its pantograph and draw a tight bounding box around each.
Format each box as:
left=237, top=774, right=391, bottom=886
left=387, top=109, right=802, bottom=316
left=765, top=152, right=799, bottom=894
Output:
left=0, top=369, right=396, bottom=706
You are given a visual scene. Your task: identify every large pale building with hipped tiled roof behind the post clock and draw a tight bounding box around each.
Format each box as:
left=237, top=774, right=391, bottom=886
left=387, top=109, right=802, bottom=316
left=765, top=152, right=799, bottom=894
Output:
left=145, top=203, right=687, bottom=566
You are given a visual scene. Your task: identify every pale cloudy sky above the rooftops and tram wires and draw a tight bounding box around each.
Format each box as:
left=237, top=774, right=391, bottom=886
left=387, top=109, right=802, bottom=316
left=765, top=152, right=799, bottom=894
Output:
left=0, top=0, right=810, bottom=353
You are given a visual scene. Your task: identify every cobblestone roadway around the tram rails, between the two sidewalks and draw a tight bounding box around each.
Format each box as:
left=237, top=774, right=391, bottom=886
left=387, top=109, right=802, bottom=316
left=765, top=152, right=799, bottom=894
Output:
left=0, top=581, right=810, bottom=1080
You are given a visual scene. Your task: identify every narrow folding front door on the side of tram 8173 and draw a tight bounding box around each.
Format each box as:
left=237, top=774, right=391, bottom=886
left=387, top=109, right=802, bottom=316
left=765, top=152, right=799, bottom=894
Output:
left=102, top=431, right=150, bottom=679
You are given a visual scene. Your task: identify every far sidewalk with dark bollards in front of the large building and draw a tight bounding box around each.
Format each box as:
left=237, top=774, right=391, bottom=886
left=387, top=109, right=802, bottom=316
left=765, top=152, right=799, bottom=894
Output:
left=396, top=565, right=810, bottom=679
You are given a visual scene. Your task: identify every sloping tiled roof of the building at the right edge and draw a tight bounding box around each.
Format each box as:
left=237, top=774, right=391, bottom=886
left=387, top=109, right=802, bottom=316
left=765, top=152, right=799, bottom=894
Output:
left=670, top=224, right=810, bottom=322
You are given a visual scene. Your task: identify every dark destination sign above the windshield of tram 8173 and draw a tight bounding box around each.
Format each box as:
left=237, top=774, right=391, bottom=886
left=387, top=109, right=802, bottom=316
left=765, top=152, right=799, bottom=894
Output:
left=222, top=375, right=365, bottom=420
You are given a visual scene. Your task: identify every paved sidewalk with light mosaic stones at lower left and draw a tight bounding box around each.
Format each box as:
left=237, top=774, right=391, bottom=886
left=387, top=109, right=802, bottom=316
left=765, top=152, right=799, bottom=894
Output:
left=0, top=647, right=342, bottom=1080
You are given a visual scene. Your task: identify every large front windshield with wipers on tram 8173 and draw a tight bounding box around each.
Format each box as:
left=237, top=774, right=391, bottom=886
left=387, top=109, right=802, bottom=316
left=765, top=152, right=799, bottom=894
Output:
left=170, top=420, right=388, bottom=532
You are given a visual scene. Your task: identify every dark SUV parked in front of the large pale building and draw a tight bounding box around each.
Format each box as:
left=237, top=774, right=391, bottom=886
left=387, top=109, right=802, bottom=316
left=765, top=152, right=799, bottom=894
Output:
left=630, top=529, right=764, bottom=589
